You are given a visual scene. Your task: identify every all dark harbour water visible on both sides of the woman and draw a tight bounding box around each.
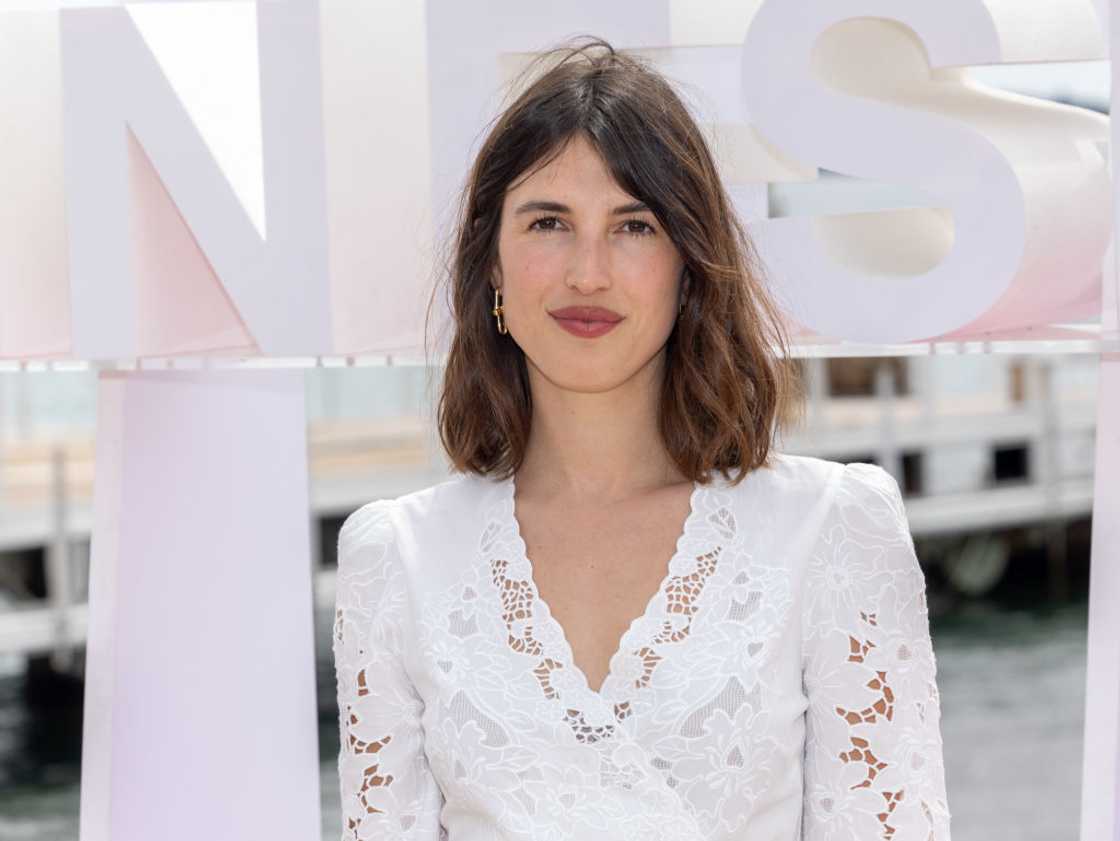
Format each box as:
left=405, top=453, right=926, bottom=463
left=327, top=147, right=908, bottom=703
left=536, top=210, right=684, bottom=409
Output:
left=0, top=599, right=1088, bottom=841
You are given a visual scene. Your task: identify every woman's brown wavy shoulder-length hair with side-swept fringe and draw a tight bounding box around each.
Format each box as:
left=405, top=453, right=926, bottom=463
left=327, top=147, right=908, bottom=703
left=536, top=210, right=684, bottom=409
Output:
left=426, top=36, right=804, bottom=484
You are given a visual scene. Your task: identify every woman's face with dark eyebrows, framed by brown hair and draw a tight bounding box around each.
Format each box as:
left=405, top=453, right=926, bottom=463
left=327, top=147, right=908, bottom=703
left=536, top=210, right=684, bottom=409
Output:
left=494, top=136, right=684, bottom=392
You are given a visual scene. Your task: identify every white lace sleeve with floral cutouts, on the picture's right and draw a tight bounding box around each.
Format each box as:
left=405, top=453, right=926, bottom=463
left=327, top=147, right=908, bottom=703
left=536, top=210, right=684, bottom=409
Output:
left=801, top=462, right=950, bottom=841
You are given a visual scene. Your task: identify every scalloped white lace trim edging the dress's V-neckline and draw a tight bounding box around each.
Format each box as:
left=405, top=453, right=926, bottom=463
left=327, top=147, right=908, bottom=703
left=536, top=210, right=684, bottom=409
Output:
left=504, top=474, right=709, bottom=705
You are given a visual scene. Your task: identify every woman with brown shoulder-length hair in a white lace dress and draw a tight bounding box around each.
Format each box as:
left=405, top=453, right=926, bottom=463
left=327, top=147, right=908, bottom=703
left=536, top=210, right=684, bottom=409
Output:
left=334, top=34, right=949, bottom=841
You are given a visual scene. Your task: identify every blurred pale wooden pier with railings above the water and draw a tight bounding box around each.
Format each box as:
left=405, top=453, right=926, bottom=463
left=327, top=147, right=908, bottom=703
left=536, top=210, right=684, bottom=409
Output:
left=0, top=356, right=1095, bottom=672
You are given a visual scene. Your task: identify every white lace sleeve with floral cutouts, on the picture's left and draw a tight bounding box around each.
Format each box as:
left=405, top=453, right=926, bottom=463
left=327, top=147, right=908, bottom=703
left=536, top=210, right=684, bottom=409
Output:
left=332, top=499, right=446, bottom=841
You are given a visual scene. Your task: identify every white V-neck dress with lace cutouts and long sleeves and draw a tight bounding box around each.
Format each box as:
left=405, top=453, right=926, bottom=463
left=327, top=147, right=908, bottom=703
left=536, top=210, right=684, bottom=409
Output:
left=333, top=454, right=950, bottom=841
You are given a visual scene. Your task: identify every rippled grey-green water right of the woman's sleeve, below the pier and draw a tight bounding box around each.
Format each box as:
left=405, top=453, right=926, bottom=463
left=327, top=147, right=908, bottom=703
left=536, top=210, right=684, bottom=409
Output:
left=934, top=601, right=1089, bottom=841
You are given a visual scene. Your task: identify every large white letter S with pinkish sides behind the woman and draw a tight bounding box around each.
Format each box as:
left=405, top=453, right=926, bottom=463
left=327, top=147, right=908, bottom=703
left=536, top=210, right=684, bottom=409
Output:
left=743, top=0, right=1111, bottom=342
